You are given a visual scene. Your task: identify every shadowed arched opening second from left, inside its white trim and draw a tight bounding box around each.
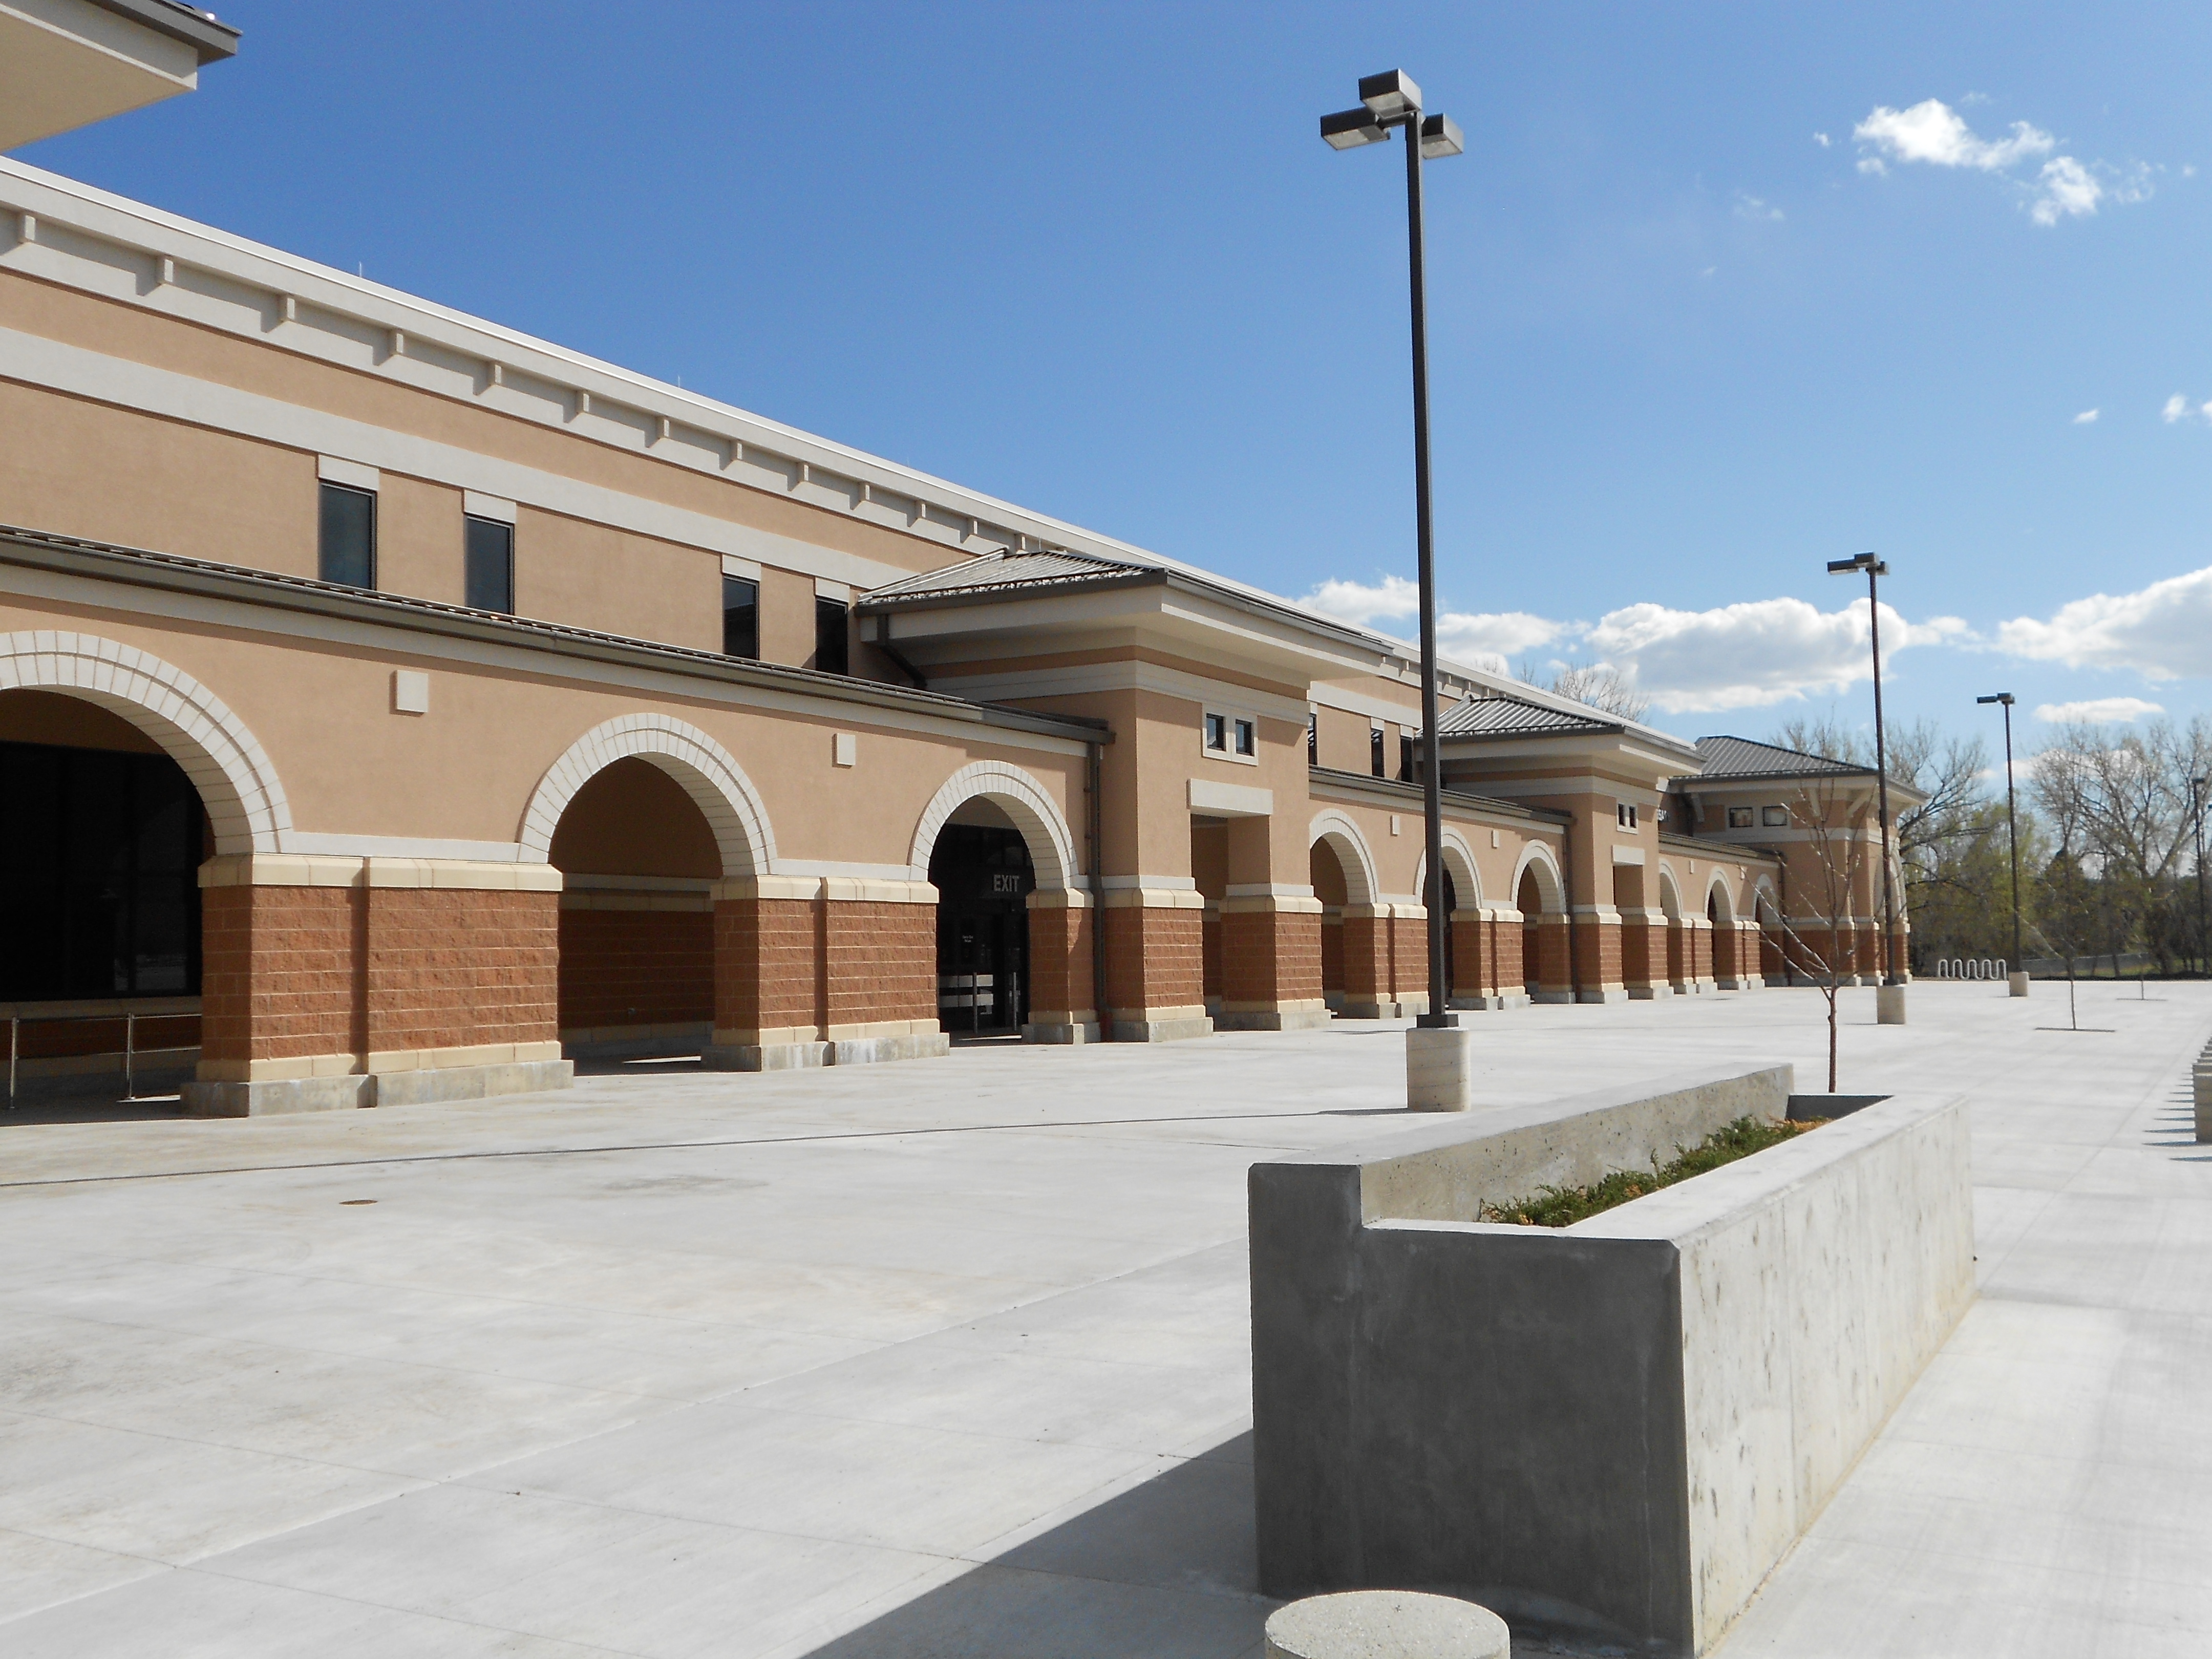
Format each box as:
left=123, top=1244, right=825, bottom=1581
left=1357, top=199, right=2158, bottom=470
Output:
left=548, top=754, right=724, bottom=1057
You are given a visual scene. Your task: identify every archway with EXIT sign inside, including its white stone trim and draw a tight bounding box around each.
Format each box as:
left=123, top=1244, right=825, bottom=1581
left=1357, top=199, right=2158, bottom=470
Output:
left=909, top=761, right=1081, bottom=1037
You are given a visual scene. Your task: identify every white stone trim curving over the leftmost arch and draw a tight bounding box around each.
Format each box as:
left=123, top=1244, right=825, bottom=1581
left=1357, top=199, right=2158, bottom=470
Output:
left=0, top=628, right=292, bottom=856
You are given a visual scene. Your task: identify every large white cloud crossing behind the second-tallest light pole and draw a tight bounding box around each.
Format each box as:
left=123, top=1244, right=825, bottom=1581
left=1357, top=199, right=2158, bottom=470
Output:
left=1582, top=600, right=1966, bottom=714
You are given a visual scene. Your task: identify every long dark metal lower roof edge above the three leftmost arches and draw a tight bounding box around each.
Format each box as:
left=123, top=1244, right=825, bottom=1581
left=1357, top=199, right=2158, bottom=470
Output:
left=0, top=524, right=1113, bottom=743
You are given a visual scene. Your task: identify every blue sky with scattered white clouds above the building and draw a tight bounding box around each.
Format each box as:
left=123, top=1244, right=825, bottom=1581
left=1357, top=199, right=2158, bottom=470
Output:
left=18, top=0, right=2212, bottom=743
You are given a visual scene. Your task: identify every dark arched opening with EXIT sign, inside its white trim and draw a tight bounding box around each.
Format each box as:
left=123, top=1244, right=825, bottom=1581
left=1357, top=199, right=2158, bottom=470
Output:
left=929, top=794, right=1037, bottom=1037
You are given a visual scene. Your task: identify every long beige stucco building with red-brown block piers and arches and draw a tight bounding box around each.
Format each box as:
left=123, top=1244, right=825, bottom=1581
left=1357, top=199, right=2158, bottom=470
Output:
left=0, top=0, right=1902, bottom=1113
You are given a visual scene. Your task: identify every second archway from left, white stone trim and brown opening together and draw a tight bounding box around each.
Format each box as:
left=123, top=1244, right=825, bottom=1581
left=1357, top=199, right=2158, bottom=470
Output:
left=522, top=714, right=774, bottom=1057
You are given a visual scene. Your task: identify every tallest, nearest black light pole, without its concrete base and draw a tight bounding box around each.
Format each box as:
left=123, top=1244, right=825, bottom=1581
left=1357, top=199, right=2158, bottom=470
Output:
left=1321, top=81, right=1466, bottom=1026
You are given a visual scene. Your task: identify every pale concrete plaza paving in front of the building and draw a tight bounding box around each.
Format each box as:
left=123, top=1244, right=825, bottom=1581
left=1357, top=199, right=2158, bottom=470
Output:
left=0, top=984, right=2212, bottom=1659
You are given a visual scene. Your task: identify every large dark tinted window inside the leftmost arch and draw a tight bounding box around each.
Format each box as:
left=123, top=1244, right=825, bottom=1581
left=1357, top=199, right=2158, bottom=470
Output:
left=0, top=743, right=201, bottom=1002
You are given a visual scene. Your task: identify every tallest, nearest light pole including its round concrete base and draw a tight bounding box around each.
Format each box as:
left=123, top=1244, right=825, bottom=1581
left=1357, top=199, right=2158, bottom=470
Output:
left=1321, top=69, right=1473, bottom=1111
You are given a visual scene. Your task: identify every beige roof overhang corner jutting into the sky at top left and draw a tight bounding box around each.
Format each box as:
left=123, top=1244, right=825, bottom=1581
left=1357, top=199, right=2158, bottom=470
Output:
left=0, top=0, right=239, bottom=151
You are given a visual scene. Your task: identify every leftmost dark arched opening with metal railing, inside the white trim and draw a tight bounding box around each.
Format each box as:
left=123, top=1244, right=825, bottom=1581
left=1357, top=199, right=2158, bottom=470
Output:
left=0, top=688, right=217, bottom=1106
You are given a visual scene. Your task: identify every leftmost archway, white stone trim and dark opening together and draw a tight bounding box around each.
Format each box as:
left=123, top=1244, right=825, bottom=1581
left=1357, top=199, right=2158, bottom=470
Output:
left=0, top=633, right=292, bottom=1097
